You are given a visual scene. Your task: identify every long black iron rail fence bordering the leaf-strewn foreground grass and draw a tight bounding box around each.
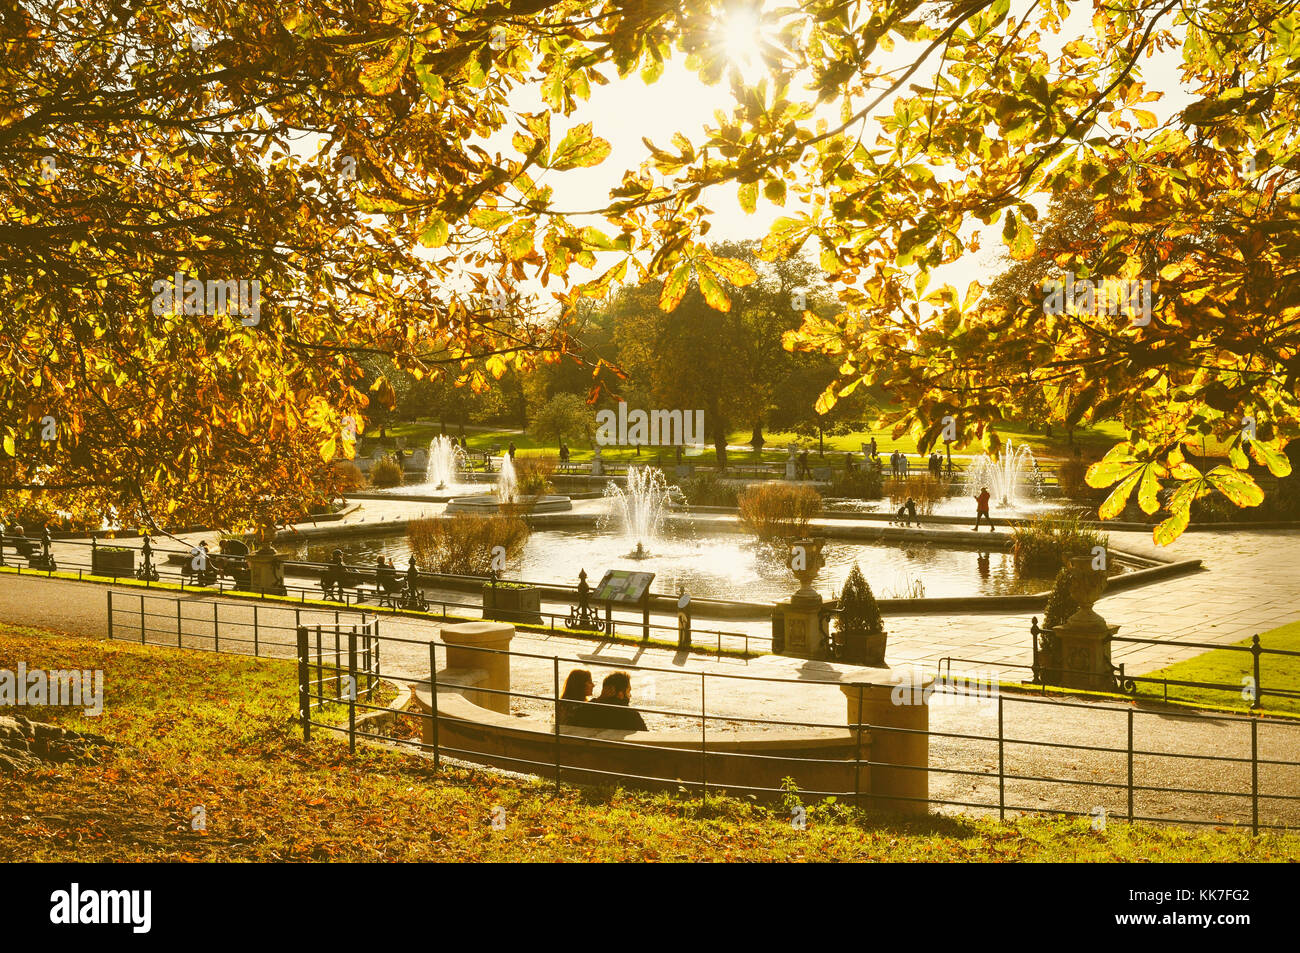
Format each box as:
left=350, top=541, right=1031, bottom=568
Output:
left=101, top=593, right=1300, bottom=832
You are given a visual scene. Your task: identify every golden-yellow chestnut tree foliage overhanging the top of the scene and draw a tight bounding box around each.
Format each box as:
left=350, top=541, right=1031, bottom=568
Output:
left=0, top=0, right=1300, bottom=540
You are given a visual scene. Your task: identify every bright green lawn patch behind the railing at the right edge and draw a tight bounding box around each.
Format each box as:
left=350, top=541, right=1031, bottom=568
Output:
left=1138, top=621, right=1300, bottom=714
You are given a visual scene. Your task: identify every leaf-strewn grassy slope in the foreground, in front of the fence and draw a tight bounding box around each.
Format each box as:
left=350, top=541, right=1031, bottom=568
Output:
left=0, top=624, right=1300, bottom=862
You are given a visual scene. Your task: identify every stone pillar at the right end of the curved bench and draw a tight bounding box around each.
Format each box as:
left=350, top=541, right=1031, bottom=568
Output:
left=840, top=670, right=933, bottom=814
